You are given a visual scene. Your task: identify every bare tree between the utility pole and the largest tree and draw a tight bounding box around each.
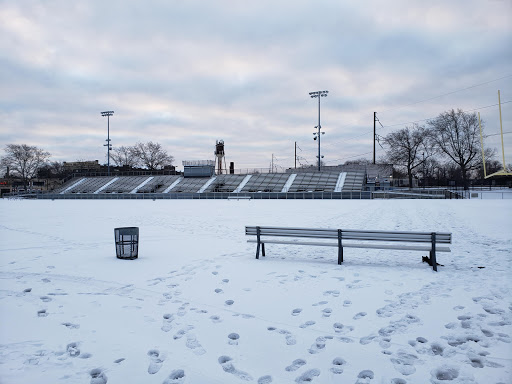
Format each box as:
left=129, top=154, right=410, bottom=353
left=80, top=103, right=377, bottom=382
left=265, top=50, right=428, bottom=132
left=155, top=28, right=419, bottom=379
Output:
left=384, top=125, right=432, bottom=186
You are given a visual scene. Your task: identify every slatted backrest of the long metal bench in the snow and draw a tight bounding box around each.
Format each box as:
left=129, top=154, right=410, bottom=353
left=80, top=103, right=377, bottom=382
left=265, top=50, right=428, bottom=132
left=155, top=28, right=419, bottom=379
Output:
left=245, top=226, right=452, bottom=244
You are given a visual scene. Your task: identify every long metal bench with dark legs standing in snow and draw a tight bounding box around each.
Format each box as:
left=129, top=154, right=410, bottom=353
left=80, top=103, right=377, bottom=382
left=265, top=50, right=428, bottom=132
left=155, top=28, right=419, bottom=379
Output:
left=245, top=226, right=452, bottom=271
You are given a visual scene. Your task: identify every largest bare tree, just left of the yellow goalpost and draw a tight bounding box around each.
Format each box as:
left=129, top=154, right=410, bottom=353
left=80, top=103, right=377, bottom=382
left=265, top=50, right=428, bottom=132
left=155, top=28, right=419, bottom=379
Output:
left=427, top=109, right=484, bottom=189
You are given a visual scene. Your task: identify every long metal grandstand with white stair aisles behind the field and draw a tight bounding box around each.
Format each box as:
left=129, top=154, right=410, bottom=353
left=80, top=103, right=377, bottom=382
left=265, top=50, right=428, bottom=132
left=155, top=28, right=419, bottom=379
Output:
left=37, top=170, right=370, bottom=199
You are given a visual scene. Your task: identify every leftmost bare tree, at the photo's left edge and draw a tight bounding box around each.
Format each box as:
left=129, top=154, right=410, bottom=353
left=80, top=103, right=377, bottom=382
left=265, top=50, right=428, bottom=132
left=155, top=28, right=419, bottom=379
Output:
left=0, top=144, right=50, bottom=188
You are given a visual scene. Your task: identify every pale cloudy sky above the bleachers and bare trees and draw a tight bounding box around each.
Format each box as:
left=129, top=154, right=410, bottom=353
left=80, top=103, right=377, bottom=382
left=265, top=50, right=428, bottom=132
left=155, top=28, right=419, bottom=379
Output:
left=0, top=0, right=512, bottom=169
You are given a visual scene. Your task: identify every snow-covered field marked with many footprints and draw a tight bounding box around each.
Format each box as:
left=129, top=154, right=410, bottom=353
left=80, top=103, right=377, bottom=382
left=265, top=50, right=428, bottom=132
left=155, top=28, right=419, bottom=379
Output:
left=0, top=199, right=512, bottom=384
